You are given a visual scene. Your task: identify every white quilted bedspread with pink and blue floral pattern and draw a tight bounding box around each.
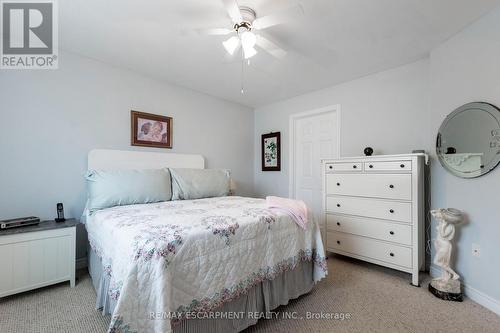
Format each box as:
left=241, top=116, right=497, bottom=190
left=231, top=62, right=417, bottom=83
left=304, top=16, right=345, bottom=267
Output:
left=86, top=197, right=327, bottom=332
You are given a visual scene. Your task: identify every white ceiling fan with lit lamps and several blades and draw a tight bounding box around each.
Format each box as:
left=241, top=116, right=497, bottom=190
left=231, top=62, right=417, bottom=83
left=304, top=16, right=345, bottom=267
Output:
left=198, top=0, right=304, bottom=59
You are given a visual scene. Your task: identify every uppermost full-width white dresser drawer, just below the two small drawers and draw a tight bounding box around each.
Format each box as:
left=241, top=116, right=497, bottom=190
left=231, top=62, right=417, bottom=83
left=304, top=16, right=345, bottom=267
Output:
left=326, top=173, right=411, bottom=200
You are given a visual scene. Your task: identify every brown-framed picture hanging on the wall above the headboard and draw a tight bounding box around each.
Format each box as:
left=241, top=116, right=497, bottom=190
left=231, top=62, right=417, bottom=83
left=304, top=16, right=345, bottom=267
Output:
left=131, top=111, right=172, bottom=148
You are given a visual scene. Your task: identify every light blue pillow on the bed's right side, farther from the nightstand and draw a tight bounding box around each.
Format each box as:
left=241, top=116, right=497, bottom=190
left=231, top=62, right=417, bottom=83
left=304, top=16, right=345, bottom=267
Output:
left=170, top=169, right=231, bottom=200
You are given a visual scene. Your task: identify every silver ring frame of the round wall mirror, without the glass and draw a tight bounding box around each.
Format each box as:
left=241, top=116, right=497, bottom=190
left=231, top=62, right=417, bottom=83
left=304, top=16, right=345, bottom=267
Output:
left=436, top=102, right=500, bottom=179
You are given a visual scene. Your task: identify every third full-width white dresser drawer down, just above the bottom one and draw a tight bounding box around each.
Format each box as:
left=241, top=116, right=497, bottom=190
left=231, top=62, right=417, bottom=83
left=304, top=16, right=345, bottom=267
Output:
left=326, top=214, right=412, bottom=245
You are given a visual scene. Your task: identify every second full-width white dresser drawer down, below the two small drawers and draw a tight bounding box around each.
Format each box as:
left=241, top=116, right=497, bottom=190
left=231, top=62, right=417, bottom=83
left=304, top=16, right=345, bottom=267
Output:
left=326, top=196, right=411, bottom=223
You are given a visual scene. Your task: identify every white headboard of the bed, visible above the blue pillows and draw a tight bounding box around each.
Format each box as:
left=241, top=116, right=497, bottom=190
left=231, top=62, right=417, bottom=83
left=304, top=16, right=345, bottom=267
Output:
left=87, top=149, right=205, bottom=170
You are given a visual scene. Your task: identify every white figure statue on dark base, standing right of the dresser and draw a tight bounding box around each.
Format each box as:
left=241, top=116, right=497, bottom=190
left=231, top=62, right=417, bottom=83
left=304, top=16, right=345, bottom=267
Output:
left=429, top=208, right=463, bottom=300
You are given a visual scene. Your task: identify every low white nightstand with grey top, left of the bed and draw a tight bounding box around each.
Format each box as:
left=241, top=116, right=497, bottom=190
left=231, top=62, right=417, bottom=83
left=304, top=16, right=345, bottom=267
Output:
left=0, top=219, right=78, bottom=297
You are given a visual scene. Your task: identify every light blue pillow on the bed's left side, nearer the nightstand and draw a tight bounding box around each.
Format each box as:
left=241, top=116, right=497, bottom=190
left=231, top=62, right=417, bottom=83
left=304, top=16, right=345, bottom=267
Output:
left=85, top=169, right=172, bottom=214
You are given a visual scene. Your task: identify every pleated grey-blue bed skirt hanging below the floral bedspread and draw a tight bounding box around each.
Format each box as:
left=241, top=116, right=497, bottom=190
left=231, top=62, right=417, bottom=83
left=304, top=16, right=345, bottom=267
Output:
left=88, top=248, right=314, bottom=333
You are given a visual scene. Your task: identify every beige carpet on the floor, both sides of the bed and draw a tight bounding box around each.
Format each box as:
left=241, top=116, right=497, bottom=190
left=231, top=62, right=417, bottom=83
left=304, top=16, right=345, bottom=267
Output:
left=0, top=256, right=500, bottom=333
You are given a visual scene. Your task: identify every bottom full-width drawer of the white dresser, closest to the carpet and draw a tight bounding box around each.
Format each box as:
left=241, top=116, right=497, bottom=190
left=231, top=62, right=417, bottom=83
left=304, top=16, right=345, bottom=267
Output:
left=327, top=232, right=412, bottom=268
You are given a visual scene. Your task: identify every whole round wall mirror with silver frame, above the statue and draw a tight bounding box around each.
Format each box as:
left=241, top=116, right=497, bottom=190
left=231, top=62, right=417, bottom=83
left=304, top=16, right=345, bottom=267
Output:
left=436, top=103, right=500, bottom=178
